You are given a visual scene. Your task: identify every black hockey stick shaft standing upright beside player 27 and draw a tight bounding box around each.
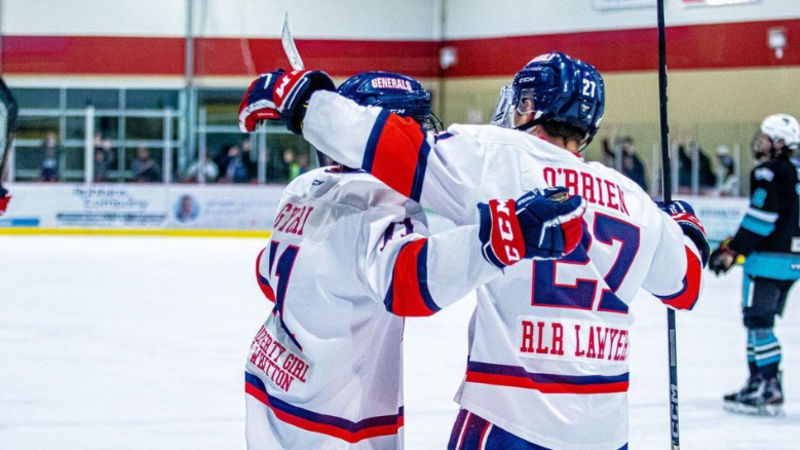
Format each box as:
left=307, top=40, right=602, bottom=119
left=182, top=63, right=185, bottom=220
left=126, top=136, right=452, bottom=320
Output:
left=657, top=0, right=681, bottom=450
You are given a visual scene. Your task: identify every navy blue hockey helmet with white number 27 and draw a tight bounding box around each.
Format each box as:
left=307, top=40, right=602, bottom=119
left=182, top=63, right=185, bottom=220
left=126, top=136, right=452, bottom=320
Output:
left=492, top=52, right=605, bottom=146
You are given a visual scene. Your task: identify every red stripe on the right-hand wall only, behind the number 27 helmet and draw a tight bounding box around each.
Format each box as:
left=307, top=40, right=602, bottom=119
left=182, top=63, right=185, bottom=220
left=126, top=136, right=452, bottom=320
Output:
left=445, top=20, right=800, bottom=77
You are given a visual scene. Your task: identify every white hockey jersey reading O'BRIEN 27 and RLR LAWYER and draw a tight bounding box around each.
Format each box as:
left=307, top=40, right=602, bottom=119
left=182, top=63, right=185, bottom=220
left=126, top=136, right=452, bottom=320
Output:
left=303, top=92, right=702, bottom=450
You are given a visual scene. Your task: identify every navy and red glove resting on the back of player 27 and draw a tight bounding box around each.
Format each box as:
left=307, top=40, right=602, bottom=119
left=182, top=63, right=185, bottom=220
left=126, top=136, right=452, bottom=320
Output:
left=478, top=188, right=586, bottom=269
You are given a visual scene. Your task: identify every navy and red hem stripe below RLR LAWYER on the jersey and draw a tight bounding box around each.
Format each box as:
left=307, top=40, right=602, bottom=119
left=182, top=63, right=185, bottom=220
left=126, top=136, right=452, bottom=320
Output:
left=467, top=361, right=629, bottom=394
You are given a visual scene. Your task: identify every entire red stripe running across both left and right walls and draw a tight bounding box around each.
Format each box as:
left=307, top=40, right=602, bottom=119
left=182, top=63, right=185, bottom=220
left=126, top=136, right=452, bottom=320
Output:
left=2, top=19, right=800, bottom=78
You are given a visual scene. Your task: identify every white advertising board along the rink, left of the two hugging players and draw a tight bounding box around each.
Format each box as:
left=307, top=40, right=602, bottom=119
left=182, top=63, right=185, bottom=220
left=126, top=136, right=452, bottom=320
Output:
left=0, top=184, right=283, bottom=230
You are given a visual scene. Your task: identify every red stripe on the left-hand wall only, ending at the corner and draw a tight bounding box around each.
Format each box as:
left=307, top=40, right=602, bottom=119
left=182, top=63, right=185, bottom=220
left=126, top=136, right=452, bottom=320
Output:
left=2, top=36, right=439, bottom=78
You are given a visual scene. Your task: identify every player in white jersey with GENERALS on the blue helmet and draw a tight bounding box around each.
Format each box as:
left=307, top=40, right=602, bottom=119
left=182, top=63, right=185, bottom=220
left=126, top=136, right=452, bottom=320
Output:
left=240, top=72, right=585, bottom=450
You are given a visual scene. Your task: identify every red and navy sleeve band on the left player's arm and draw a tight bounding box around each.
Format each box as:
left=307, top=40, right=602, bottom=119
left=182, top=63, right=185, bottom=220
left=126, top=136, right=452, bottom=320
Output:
left=383, top=239, right=441, bottom=317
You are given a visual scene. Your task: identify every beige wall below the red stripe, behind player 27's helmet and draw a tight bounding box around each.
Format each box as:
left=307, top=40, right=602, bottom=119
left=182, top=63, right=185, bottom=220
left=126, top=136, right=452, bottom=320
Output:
left=440, top=68, right=800, bottom=190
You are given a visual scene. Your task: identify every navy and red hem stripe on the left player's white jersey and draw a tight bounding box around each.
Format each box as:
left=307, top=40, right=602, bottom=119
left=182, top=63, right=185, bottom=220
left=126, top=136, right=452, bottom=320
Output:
left=245, top=372, right=404, bottom=444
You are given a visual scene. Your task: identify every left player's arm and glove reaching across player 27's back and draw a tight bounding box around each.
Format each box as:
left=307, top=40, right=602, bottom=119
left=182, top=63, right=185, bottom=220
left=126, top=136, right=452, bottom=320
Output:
left=361, top=189, right=586, bottom=316
